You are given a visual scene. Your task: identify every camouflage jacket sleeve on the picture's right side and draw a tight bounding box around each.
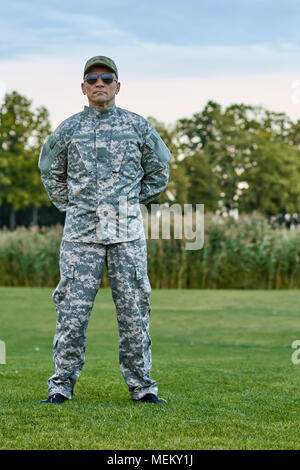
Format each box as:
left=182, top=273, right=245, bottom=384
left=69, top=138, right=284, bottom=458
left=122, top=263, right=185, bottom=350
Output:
left=139, top=126, right=171, bottom=204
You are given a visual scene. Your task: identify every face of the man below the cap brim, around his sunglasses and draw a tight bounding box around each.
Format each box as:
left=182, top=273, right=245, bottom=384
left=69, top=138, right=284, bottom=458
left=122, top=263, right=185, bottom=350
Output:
left=81, top=66, right=120, bottom=109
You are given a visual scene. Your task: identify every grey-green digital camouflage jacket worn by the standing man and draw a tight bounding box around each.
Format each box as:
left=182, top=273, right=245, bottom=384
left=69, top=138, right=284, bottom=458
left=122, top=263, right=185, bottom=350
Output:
left=38, top=104, right=170, bottom=244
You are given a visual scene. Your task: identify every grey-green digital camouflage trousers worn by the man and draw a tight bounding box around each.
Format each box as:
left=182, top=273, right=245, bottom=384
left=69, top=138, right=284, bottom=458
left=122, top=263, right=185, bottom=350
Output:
left=48, top=238, right=157, bottom=400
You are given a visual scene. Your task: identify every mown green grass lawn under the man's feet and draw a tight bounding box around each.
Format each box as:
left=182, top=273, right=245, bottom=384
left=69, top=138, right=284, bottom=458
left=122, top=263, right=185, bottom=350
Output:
left=0, top=288, right=300, bottom=450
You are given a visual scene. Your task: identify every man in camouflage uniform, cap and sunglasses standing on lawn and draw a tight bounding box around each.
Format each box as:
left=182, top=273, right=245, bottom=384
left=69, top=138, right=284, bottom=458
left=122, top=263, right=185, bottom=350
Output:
left=39, top=56, right=170, bottom=403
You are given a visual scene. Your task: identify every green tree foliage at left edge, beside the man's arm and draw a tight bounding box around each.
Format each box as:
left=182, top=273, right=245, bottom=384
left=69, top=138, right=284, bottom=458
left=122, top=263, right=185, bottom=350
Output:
left=0, top=91, right=51, bottom=228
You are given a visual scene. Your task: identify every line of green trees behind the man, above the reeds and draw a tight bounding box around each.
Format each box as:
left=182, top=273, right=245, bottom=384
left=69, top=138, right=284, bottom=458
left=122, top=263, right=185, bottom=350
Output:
left=0, top=91, right=300, bottom=230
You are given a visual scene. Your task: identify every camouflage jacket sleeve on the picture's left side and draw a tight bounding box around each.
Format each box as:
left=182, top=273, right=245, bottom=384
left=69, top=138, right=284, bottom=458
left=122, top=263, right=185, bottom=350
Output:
left=38, top=131, right=68, bottom=212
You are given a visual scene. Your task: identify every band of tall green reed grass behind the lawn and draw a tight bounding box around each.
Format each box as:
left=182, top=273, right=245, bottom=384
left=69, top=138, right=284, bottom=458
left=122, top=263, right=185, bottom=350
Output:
left=0, top=214, right=300, bottom=289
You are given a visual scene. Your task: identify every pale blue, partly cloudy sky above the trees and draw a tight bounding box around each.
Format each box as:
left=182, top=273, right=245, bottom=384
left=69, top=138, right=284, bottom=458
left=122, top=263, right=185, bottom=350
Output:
left=0, top=0, right=300, bottom=126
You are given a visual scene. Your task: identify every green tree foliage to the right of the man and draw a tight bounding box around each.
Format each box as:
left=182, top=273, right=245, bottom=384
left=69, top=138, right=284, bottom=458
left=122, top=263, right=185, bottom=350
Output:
left=177, top=101, right=300, bottom=215
